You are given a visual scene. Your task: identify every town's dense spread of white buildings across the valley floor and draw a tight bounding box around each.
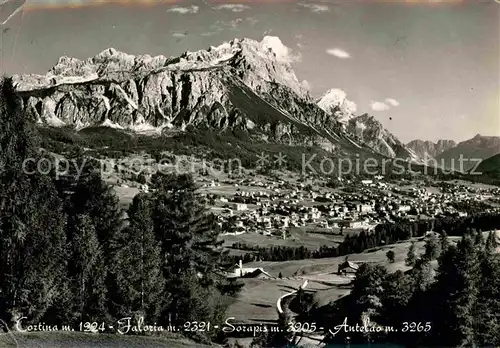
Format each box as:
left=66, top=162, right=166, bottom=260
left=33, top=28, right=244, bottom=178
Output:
left=202, top=174, right=500, bottom=239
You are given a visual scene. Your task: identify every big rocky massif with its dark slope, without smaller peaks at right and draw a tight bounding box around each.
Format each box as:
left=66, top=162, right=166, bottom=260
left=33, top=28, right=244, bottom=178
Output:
left=12, top=36, right=336, bottom=141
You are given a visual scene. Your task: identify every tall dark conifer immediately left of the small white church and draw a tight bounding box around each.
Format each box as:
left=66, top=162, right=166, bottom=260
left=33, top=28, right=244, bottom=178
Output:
left=152, top=174, right=229, bottom=338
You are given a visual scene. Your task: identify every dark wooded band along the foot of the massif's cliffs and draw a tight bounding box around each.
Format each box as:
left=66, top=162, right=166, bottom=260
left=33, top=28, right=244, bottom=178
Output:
left=40, top=127, right=336, bottom=170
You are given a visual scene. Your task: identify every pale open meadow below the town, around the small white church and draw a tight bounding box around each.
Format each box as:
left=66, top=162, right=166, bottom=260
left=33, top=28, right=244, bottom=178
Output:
left=227, top=241, right=424, bottom=322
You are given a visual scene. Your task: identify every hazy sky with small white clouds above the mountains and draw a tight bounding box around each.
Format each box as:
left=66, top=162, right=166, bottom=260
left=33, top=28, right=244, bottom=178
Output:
left=0, top=0, right=500, bottom=142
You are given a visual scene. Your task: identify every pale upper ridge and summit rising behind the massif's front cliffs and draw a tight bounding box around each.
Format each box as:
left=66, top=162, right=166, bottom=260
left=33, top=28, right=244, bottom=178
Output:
left=14, top=36, right=310, bottom=95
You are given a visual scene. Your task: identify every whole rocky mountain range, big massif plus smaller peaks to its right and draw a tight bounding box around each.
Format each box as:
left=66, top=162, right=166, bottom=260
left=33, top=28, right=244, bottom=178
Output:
left=8, top=36, right=500, bottom=170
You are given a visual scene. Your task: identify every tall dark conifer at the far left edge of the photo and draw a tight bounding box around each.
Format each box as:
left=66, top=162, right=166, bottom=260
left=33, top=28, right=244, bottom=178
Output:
left=0, top=78, right=66, bottom=322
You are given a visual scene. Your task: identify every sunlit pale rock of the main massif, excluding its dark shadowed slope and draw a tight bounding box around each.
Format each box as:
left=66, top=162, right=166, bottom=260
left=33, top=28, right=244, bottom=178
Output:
left=14, top=39, right=314, bottom=129
